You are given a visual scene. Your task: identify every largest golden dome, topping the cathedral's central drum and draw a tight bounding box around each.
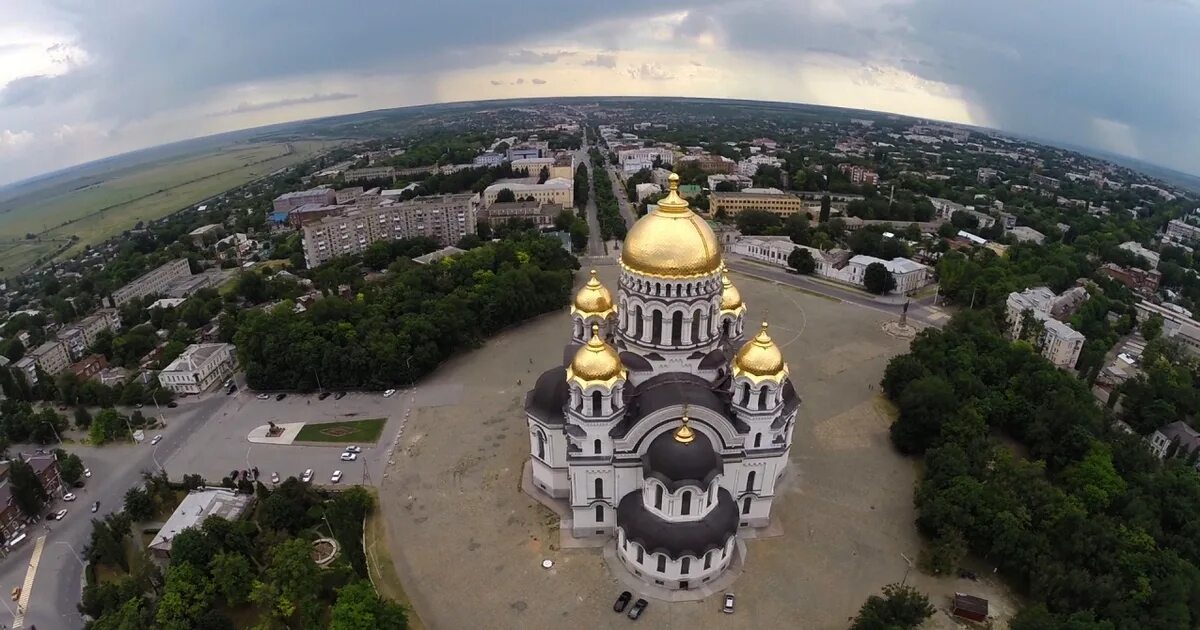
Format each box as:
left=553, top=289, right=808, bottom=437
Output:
left=620, top=173, right=721, bottom=278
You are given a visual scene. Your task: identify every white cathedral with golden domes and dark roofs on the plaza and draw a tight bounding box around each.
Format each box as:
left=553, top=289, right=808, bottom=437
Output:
left=526, top=174, right=800, bottom=589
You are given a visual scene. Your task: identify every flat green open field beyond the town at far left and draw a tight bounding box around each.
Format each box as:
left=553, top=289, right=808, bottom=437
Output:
left=0, top=140, right=336, bottom=276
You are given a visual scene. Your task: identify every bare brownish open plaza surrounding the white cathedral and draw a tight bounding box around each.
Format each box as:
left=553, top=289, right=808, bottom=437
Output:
left=380, top=266, right=1017, bottom=629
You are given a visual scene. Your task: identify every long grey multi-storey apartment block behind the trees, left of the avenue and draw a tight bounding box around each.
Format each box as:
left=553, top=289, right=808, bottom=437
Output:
left=304, top=193, right=475, bottom=268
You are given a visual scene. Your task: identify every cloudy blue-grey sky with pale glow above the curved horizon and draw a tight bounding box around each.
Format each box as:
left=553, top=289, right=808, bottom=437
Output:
left=0, top=0, right=1200, bottom=184
